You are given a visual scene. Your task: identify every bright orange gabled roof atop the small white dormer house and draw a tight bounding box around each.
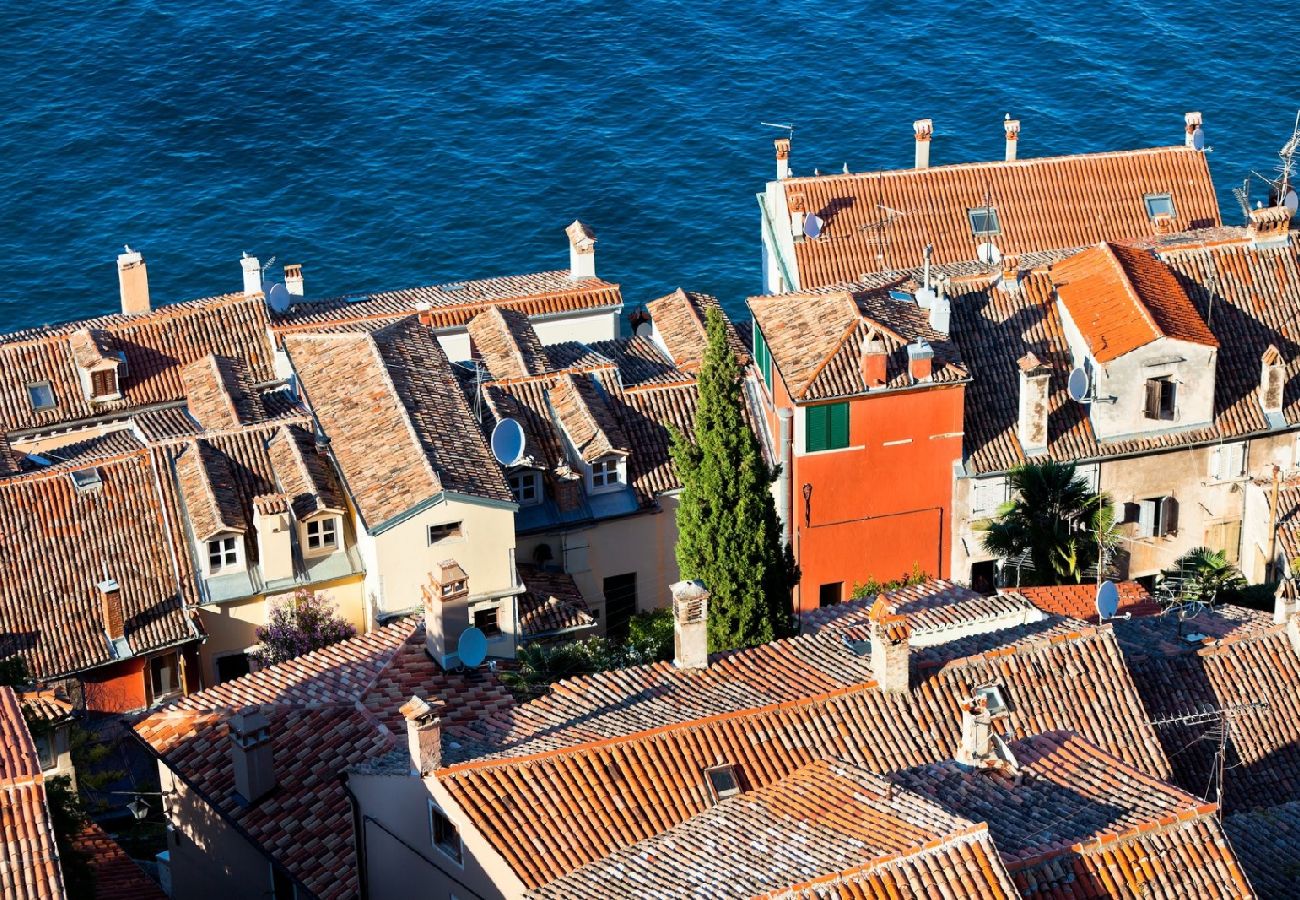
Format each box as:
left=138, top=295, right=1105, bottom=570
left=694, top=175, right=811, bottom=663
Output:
left=1052, top=243, right=1218, bottom=363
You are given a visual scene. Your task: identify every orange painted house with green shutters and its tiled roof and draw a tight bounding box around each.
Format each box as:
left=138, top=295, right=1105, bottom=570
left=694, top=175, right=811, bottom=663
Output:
left=749, top=288, right=969, bottom=611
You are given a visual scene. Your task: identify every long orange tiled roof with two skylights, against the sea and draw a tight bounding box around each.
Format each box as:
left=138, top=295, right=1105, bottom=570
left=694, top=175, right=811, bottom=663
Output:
left=776, top=147, right=1219, bottom=290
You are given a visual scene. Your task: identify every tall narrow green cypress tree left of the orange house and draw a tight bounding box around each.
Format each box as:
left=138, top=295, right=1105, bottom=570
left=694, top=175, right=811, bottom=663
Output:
left=672, top=310, right=793, bottom=652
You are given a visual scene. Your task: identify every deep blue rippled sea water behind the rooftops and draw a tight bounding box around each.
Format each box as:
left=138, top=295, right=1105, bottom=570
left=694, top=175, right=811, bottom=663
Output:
left=0, top=0, right=1300, bottom=330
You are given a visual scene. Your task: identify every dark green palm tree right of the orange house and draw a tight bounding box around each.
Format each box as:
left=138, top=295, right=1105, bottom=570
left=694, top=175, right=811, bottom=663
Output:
left=979, top=460, right=1119, bottom=584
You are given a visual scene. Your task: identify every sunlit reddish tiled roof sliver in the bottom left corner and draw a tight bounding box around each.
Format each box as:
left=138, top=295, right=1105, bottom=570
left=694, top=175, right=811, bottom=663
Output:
left=0, top=687, right=66, bottom=900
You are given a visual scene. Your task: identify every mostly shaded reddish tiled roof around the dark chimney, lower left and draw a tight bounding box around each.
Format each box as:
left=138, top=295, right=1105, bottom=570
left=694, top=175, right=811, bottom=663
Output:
left=135, top=622, right=511, bottom=900
